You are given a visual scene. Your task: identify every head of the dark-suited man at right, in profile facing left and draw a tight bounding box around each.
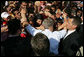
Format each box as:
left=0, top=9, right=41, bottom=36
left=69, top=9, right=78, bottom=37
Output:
left=67, top=16, right=81, bottom=30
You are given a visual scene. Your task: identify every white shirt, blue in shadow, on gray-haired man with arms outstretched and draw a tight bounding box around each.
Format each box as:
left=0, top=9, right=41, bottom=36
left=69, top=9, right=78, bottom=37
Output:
left=26, top=25, right=66, bottom=54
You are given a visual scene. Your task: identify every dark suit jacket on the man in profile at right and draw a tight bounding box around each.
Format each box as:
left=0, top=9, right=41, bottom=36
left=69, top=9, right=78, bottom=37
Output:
left=58, top=31, right=80, bottom=56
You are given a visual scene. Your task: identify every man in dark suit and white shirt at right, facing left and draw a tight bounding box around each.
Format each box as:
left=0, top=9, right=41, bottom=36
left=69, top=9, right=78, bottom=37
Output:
left=59, top=16, right=81, bottom=56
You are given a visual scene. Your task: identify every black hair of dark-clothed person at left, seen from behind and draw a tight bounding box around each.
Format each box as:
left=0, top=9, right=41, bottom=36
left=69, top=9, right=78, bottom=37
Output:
left=8, top=19, right=21, bottom=34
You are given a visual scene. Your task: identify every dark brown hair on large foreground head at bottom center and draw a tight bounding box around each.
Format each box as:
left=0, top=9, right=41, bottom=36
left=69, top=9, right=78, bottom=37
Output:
left=31, top=33, right=50, bottom=56
